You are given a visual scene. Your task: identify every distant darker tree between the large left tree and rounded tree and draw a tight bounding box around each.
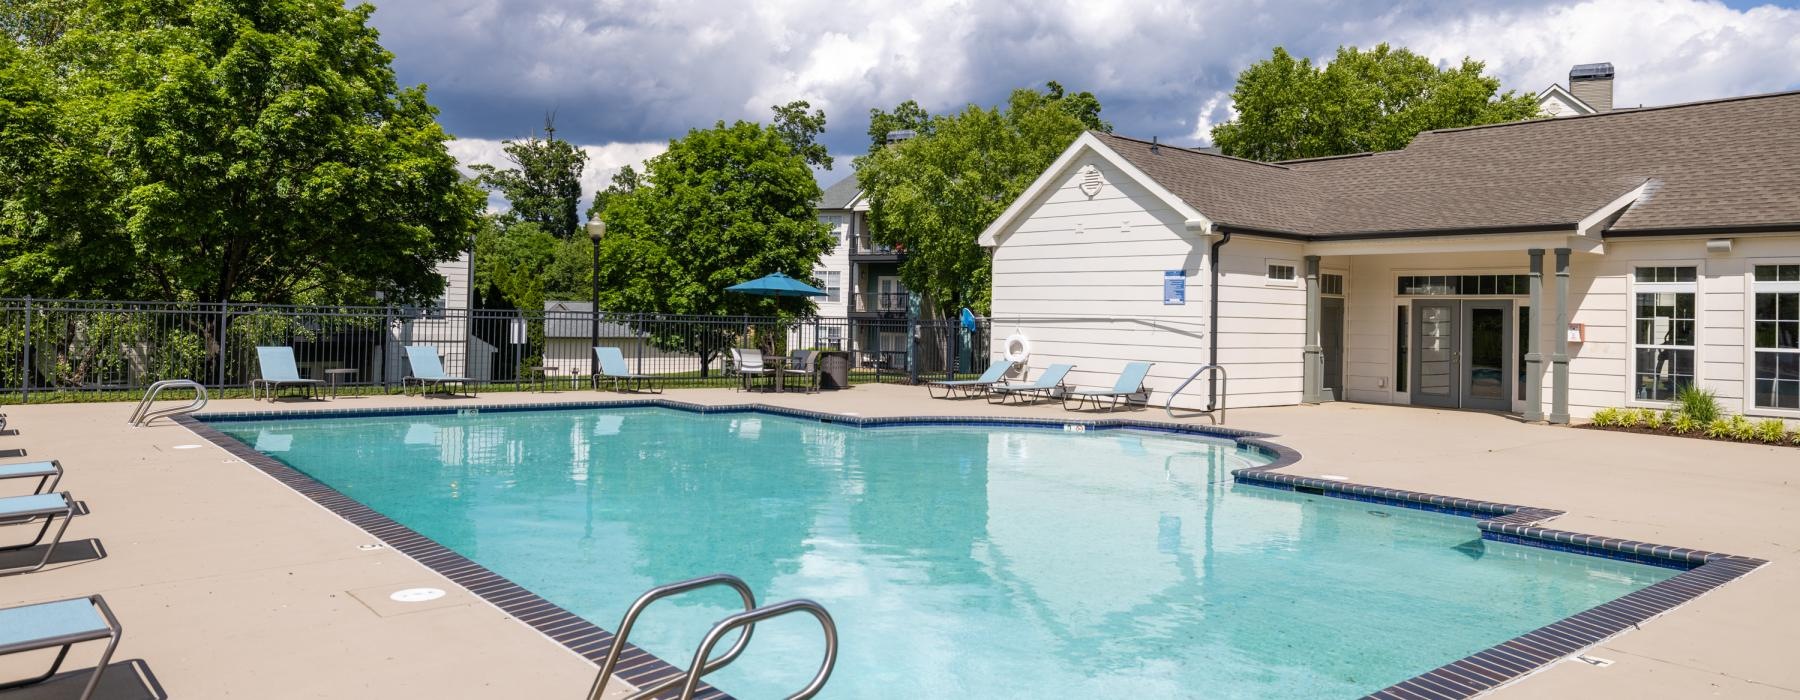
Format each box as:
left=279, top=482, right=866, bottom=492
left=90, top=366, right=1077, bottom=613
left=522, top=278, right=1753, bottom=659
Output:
left=472, top=115, right=587, bottom=239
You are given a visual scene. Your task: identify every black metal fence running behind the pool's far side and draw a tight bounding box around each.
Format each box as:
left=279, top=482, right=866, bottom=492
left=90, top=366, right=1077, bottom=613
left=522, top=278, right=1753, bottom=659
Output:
left=0, top=299, right=988, bottom=401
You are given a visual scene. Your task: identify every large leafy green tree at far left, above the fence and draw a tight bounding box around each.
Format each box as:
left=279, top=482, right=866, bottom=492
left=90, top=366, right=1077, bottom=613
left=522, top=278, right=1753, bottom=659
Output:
left=0, top=0, right=482, bottom=302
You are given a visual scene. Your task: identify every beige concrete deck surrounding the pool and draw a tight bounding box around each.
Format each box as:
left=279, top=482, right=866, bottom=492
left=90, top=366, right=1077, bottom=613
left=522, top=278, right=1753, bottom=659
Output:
left=0, top=385, right=1800, bottom=698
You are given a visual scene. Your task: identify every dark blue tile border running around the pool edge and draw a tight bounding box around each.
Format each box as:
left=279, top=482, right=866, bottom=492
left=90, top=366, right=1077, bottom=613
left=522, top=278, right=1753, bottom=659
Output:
left=175, top=398, right=1766, bottom=700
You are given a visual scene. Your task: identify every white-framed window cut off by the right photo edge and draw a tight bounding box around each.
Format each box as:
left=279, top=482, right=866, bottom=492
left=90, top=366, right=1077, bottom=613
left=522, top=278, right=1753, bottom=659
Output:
left=1751, top=265, right=1800, bottom=410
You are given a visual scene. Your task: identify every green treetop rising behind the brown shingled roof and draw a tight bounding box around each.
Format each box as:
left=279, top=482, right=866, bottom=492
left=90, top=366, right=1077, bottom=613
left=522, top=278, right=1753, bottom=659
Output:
left=1213, top=43, right=1539, bottom=160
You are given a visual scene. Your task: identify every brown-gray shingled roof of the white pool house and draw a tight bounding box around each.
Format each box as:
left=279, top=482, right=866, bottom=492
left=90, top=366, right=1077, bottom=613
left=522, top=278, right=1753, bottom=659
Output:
left=1098, top=92, right=1800, bottom=238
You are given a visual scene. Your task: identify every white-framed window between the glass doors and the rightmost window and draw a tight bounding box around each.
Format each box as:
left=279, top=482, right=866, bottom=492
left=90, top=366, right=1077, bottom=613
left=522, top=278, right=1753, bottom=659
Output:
left=1633, top=266, right=1696, bottom=401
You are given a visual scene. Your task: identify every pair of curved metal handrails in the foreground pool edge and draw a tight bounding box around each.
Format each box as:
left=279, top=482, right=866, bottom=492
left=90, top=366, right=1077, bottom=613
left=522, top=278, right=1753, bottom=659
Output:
left=587, top=574, right=837, bottom=700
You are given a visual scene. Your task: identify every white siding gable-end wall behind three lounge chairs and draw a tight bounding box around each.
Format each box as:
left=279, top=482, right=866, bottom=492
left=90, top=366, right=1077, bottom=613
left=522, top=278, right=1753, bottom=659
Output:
left=992, top=157, right=1231, bottom=407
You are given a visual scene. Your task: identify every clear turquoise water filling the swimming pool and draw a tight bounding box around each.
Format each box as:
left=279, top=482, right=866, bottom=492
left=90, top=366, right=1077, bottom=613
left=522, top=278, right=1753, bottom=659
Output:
left=216, top=408, right=1676, bottom=698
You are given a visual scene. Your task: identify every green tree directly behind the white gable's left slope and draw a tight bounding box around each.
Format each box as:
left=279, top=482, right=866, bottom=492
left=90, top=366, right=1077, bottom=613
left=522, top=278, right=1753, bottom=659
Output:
left=857, top=83, right=1112, bottom=315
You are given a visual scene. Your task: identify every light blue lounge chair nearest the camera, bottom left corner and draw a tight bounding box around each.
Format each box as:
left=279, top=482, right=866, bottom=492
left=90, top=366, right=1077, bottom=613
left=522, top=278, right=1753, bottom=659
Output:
left=0, top=596, right=124, bottom=700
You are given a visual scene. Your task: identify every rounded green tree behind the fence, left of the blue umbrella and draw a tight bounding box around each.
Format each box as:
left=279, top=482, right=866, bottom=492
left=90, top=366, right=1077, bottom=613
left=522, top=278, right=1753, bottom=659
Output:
left=599, top=121, right=833, bottom=372
